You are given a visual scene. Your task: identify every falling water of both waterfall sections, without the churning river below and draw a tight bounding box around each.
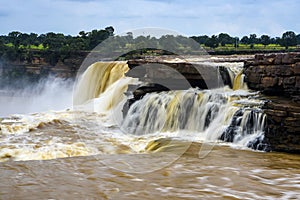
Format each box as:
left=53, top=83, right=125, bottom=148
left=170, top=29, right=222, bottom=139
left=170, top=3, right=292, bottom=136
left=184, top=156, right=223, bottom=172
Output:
left=74, top=62, right=267, bottom=150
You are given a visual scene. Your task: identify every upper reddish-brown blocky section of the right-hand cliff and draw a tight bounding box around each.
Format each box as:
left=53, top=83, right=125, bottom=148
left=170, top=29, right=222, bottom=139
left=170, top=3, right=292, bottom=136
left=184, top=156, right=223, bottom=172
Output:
left=245, top=53, right=300, bottom=101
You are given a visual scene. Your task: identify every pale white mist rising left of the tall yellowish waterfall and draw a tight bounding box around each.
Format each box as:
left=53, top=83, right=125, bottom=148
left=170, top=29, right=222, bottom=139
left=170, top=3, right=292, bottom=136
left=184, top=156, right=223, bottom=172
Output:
left=0, top=76, right=74, bottom=117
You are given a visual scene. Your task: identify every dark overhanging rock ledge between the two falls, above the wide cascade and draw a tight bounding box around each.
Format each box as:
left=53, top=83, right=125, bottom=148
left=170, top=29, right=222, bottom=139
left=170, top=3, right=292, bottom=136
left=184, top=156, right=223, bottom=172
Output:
left=127, top=59, right=232, bottom=90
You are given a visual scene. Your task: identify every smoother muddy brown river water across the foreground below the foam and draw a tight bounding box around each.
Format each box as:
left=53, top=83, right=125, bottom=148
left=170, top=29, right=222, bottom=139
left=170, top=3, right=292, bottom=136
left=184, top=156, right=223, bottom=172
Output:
left=0, top=143, right=300, bottom=199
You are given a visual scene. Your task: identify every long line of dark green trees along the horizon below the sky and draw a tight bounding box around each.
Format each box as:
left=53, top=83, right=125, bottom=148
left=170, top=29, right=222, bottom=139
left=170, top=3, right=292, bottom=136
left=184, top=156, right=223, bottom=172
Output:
left=0, top=26, right=300, bottom=65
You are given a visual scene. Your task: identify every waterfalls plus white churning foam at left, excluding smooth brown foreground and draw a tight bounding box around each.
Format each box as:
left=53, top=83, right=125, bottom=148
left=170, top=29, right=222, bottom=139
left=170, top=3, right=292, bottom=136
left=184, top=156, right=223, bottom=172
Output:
left=0, top=59, right=268, bottom=161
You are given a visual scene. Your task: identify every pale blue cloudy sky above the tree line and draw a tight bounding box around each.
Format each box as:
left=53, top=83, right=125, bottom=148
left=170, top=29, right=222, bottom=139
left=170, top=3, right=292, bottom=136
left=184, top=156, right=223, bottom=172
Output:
left=0, top=0, right=300, bottom=37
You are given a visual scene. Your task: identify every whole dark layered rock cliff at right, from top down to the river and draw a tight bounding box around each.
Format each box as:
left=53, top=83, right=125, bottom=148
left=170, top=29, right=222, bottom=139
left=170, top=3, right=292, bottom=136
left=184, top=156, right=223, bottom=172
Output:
left=244, top=53, right=300, bottom=153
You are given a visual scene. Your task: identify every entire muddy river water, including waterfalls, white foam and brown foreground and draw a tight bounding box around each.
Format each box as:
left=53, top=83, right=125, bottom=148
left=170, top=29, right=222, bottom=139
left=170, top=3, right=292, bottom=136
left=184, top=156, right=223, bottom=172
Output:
left=0, top=62, right=300, bottom=199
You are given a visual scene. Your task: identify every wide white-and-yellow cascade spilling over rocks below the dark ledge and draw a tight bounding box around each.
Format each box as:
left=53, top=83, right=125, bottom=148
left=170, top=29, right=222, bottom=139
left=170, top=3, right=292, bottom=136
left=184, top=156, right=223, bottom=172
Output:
left=122, top=89, right=265, bottom=150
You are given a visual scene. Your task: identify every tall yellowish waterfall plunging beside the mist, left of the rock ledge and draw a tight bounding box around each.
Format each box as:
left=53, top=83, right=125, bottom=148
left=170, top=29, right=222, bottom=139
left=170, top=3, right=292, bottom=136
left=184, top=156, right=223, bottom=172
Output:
left=73, top=62, right=138, bottom=113
